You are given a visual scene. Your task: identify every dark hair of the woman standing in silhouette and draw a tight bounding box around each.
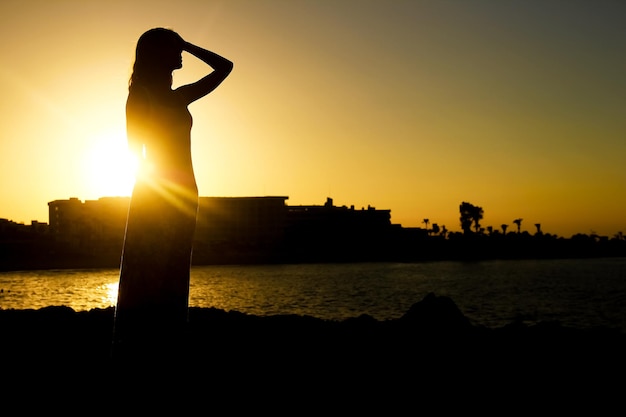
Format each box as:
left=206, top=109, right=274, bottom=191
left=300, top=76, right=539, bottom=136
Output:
left=129, top=28, right=182, bottom=89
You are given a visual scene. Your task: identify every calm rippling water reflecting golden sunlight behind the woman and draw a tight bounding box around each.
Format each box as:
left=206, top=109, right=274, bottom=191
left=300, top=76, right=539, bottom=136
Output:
left=0, top=258, right=626, bottom=332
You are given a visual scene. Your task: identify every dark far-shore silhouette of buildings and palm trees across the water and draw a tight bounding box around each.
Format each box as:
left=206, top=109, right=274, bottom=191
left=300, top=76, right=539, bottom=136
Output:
left=0, top=196, right=626, bottom=270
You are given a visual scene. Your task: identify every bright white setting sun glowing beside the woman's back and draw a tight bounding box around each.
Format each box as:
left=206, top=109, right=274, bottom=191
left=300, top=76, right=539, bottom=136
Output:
left=83, top=127, right=137, bottom=197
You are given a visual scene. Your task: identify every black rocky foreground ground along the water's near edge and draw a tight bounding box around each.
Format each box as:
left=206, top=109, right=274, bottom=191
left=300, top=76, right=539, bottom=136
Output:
left=0, top=294, right=626, bottom=415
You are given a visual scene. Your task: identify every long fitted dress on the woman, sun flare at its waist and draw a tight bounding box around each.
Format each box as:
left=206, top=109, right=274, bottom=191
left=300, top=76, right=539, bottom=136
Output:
left=113, top=89, right=198, bottom=358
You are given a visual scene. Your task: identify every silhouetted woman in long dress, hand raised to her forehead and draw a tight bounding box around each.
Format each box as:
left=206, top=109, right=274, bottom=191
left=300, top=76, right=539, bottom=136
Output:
left=114, top=28, right=233, bottom=357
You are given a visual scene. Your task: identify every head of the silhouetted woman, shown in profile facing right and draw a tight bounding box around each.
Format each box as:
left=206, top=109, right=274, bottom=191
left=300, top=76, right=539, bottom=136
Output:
left=130, top=28, right=184, bottom=89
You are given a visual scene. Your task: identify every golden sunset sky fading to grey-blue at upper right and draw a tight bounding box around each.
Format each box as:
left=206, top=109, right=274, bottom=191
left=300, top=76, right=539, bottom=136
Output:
left=0, top=0, right=626, bottom=237
